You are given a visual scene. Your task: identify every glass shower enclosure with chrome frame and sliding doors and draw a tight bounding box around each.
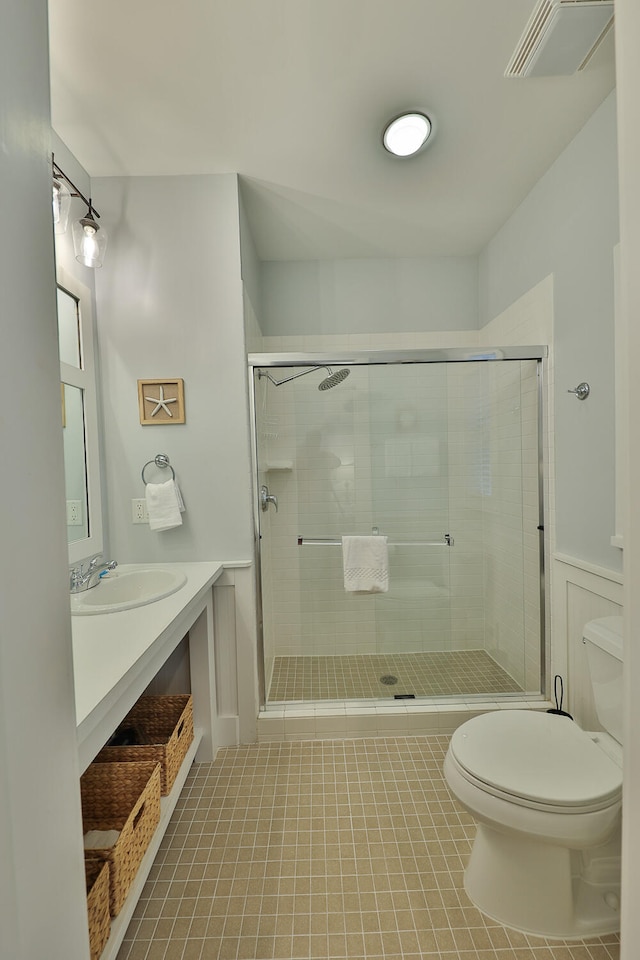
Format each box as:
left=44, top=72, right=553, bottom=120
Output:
left=249, top=347, right=546, bottom=705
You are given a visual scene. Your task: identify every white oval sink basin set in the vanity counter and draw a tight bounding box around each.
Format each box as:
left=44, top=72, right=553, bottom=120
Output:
left=71, top=567, right=187, bottom=616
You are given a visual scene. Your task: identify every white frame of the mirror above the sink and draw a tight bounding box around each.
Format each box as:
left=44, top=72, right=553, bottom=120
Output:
left=56, top=266, right=104, bottom=564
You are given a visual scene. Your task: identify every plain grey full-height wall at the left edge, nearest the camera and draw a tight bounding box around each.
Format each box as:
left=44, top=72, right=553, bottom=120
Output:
left=0, top=0, right=89, bottom=960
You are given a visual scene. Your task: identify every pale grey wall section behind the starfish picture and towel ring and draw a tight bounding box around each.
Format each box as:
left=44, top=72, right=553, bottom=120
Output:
left=93, top=175, right=253, bottom=562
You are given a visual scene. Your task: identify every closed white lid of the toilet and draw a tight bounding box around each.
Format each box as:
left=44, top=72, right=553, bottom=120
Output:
left=450, top=710, right=622, bottom=807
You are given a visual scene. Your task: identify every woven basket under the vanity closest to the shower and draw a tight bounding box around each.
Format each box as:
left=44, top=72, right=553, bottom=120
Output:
left=96, top=694, right=193, bottom=797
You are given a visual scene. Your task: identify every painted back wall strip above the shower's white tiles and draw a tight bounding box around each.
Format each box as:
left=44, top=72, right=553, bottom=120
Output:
left=261, top=257, right=478, bottom=336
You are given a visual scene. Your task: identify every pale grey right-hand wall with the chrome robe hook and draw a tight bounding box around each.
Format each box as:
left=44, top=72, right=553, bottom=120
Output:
left=480, top=94, right=621, bottom=570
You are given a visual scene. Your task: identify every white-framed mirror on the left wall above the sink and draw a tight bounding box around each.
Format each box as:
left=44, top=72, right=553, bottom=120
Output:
left=57, top=269, right=102, bottom=563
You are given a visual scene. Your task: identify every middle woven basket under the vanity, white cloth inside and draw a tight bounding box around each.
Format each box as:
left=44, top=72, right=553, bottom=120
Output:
left=80, top=763, right=160, bottom=917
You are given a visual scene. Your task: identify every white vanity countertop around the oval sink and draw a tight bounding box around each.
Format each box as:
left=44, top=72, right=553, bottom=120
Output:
left=71, top=561, right=225, bottom=769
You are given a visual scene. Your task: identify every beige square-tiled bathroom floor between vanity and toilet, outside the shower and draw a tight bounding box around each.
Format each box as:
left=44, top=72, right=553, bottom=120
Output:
left=118, top=736, right=620, bottom=960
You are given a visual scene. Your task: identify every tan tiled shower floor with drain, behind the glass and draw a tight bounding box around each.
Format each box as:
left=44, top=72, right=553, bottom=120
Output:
left=268, top=650, right=522, bottom=703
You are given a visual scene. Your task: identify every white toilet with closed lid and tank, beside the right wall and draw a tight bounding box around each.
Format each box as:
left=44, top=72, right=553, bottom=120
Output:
left=444, top=617, right=622, bottom=939
